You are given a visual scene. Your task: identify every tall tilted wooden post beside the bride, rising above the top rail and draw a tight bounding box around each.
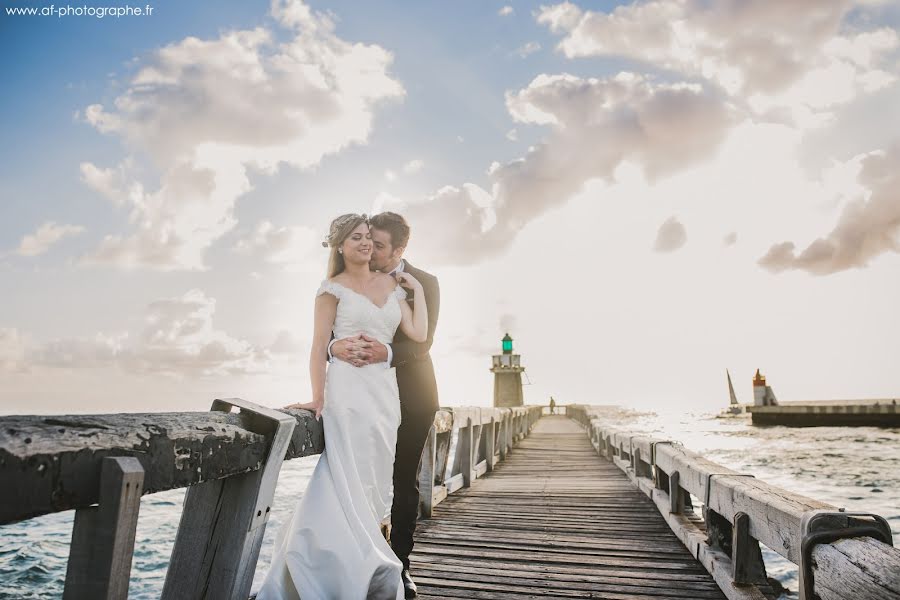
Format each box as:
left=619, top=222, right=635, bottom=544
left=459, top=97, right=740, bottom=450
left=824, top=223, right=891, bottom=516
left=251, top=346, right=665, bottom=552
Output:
left=162, top=398, right=297, bottom=600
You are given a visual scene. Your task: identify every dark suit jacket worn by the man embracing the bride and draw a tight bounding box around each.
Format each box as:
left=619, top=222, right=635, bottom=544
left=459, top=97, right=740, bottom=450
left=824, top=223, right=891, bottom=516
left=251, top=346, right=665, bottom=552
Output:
left=391, top=262, right=441, bottom=413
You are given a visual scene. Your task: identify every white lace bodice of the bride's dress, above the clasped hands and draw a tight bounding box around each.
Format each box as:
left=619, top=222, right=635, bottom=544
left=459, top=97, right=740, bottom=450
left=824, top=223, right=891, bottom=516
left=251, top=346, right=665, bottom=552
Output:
left=316, top=279, right=406, bottom=344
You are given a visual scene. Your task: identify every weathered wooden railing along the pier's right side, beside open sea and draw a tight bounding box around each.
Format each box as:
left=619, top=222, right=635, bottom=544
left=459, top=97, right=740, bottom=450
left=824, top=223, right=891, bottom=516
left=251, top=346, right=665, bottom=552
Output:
left=567, top=406, right=900, bottom=600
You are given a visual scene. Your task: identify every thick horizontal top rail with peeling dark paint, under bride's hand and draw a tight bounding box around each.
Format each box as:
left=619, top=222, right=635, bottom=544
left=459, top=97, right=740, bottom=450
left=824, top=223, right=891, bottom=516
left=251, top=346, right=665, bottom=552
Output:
left=0, top=410, right=325, bottom=524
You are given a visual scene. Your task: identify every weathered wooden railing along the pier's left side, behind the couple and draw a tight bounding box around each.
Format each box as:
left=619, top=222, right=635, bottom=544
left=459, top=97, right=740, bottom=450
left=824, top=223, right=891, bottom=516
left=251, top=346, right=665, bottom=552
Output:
left=0, top=399, right=541, bottom=600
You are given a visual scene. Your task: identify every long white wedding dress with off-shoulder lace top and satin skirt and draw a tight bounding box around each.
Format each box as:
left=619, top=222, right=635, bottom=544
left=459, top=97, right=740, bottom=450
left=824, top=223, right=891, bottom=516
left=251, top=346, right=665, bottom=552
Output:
left=257, top=281, right=406, bottom=600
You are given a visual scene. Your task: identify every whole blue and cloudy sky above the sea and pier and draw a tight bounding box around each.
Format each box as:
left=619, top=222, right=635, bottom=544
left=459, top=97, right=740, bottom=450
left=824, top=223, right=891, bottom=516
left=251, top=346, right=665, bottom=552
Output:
left=0, top=0, right=900, bottom=414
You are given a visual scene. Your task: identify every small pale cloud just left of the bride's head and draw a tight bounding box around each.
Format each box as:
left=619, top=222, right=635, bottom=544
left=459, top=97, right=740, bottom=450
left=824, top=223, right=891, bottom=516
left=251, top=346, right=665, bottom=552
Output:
left=235, top=221, right=322, bottom=270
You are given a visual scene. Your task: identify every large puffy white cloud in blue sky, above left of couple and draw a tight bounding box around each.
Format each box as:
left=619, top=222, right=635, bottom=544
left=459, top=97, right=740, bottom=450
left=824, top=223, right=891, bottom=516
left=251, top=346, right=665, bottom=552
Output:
left=82, top=0, right=404, bottom=270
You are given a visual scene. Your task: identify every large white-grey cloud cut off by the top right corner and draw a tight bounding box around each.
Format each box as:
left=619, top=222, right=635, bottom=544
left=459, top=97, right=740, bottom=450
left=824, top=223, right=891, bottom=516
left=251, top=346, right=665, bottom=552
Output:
left=537, top=0, right=898, bottom=118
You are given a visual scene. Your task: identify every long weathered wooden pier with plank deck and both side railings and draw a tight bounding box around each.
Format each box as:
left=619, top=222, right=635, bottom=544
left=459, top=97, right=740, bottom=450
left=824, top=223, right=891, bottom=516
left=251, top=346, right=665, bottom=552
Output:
left=0, top=399, right=900, bottom=600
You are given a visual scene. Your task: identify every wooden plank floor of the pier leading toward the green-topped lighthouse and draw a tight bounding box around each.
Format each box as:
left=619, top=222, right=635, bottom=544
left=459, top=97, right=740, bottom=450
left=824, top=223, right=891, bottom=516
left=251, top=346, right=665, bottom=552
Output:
left=410, top=416, right=725, bottom=600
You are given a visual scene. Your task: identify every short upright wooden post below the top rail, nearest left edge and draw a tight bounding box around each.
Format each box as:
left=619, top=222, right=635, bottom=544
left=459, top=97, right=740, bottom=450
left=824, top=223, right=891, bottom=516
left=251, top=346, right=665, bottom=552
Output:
left=63, top=456, right=144, bottom=600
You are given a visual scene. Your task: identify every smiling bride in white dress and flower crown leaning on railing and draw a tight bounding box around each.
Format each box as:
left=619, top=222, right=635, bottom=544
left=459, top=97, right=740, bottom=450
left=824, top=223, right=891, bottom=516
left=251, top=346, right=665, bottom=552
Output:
left=257, top=214, right=428, bottom=600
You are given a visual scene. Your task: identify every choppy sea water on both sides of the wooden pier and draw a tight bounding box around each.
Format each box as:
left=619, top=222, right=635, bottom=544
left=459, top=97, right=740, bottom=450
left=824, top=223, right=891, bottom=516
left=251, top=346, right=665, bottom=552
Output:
left=0, top=408, right=900, bottom=600
